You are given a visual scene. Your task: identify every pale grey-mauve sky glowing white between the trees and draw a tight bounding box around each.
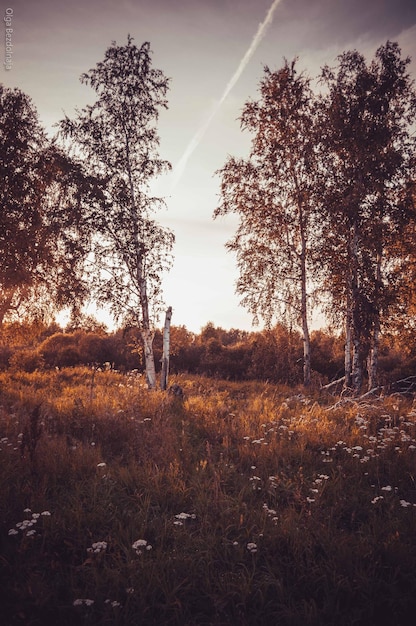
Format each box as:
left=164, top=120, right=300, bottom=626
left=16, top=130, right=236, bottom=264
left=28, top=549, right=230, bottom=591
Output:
left=1, top=0, right=416, bottom=332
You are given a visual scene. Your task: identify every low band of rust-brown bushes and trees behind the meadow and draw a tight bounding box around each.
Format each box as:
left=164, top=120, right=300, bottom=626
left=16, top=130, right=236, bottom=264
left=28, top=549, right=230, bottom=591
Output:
left=0, top=323, right=416, bottom=386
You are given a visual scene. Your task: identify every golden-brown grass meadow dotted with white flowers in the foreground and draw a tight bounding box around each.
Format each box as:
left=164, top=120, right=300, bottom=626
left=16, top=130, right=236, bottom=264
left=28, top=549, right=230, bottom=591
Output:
left=0, top=368, right=416, bottom=626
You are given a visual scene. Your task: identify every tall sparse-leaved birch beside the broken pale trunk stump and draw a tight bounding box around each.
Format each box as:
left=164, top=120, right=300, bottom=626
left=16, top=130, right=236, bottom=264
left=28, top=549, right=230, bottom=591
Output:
left=61, top=36, right=174, bottom=388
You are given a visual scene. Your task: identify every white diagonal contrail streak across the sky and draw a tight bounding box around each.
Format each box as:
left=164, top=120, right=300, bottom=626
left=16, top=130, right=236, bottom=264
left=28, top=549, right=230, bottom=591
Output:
left=170, top=0, right=280, bottom=193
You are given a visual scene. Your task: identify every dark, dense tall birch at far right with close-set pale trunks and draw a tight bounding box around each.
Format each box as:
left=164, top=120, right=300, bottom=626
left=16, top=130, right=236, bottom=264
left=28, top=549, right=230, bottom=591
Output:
left=320, top=42, right=416, bottom=393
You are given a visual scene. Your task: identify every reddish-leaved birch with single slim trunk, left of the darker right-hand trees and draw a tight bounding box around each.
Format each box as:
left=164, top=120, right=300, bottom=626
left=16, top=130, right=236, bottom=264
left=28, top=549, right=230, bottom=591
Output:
left=214, top=61, right=317, bottom=385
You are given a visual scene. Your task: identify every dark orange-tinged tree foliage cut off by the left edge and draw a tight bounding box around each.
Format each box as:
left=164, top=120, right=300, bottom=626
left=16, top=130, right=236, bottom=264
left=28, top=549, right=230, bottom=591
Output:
left=0, top=86, right=95, bottom=324
